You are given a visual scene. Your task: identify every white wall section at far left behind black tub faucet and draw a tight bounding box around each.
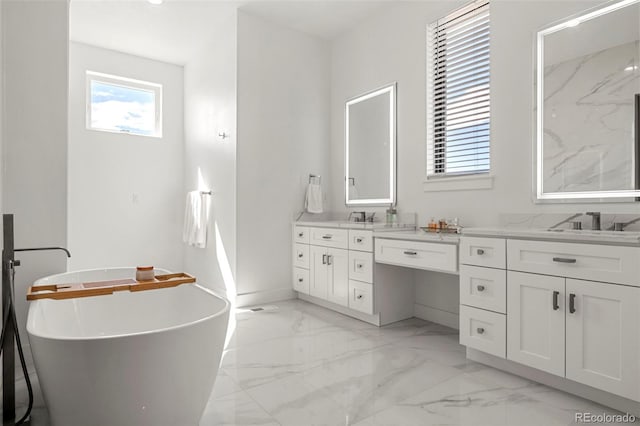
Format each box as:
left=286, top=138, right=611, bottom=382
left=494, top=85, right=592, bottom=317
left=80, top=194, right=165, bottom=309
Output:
left=0, top=0, right=68, bottom=352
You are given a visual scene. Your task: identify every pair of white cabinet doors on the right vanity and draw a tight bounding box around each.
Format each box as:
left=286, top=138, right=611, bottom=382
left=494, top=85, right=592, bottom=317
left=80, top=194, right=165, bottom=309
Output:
left=507, top=271, right=640, bottom=401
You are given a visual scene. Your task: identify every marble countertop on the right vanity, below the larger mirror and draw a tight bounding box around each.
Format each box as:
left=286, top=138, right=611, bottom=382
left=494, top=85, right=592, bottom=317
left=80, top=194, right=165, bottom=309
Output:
left=462, top=228, right=640, bottom=246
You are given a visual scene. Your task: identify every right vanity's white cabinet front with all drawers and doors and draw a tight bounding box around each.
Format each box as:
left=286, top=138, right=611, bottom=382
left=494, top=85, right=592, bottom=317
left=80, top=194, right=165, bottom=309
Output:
left=460, top=237, right=640, bottom=401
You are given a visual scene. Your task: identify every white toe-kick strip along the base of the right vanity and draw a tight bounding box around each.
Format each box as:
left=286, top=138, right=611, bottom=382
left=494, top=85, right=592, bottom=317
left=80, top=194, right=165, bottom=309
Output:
left=467, top=348, right=640, bottom=417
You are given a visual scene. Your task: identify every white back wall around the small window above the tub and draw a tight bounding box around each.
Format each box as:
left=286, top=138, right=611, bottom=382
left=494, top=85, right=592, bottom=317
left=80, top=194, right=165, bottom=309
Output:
left=68, top=42, right=185, bottom=271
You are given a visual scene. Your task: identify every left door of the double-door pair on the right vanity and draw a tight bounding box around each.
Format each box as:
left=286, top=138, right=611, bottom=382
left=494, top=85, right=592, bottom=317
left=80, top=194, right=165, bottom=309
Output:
left=507, top=271, right=565, bottom=376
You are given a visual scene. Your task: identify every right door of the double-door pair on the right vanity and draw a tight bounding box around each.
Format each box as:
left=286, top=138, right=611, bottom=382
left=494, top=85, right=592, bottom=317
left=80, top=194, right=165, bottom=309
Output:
left=566, top=279, right=640, bottom=401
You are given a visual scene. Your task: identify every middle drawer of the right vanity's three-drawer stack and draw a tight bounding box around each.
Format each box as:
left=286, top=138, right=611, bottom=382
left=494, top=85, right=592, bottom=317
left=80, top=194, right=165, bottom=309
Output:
left=460, top=265, right=507, bottom=314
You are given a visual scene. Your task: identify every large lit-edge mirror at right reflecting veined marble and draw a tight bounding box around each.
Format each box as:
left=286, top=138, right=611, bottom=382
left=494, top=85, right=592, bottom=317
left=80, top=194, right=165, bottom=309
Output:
left=536, top=0, right=640, bottom=201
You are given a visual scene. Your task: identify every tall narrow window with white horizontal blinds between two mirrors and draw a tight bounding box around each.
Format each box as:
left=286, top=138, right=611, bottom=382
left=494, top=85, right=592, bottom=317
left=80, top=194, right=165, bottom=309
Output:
left=427, top=0, right=490, bottom=177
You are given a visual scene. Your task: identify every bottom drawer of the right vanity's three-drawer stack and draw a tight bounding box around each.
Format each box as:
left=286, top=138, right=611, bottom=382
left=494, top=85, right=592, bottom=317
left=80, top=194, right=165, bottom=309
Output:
left=460, top=306, right=507, bottom=358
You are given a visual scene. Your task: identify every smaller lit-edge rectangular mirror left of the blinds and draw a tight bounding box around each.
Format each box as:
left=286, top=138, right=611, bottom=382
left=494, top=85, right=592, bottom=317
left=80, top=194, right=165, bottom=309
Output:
left=345, top=83, right=396, bottom=206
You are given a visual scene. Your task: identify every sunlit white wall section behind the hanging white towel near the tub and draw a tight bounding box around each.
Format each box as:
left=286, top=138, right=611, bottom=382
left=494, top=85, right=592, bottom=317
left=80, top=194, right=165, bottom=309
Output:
left=183, top=11, right=237, bottom=299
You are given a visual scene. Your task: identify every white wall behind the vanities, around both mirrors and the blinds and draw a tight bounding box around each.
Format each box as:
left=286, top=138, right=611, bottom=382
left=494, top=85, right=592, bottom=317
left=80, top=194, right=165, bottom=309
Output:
left=331, top=0, right=640, bottom=326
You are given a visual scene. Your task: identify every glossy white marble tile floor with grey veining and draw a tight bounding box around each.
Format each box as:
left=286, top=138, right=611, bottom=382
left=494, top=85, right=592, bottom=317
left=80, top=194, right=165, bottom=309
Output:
left=3, top=300, right=636, bottom=426
